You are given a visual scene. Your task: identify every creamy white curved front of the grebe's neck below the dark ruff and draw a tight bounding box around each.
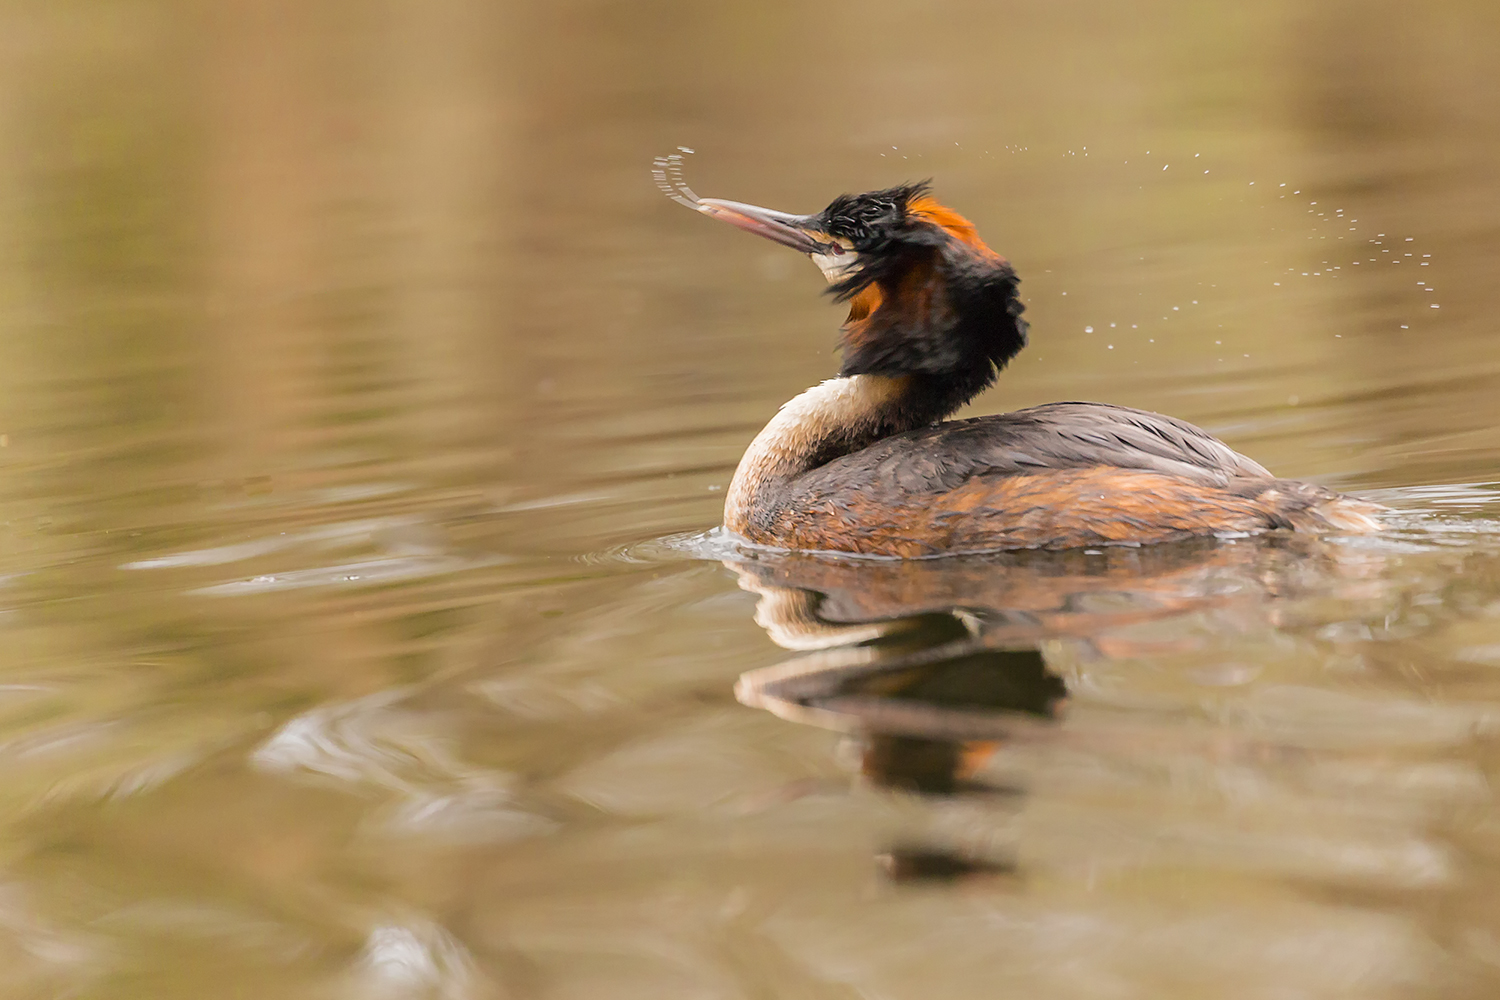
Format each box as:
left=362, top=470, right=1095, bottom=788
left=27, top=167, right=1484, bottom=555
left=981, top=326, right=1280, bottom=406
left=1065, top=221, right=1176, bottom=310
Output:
left=725, top=375, right=905, bottom=534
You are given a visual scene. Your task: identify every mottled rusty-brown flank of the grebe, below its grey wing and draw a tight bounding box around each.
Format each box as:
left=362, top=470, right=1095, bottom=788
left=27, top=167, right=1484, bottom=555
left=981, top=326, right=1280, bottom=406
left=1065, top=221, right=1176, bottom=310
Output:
left=741, top=466, right=1373, bottom=558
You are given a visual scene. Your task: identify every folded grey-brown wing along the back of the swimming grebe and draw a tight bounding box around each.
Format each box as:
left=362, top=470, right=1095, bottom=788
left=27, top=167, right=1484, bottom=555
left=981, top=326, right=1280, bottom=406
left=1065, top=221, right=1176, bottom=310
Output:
left=798, top=403, right=1274, bottom=493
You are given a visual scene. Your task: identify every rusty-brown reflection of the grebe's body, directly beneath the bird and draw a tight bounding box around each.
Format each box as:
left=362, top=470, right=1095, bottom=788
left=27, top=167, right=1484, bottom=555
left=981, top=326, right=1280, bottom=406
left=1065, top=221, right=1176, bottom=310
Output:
left=728, top=535, right=1382, bottom=655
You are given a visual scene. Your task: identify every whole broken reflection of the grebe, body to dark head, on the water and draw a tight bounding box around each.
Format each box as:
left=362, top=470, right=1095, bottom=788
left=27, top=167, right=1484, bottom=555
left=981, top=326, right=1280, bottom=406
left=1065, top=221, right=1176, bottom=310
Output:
left=726, top=535, right=1389, bottom=879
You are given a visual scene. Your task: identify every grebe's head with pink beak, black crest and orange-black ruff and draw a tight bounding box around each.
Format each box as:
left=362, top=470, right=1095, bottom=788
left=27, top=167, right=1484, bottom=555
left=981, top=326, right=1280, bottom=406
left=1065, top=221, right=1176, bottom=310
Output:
left=696, top=183, right=1026, bottom=399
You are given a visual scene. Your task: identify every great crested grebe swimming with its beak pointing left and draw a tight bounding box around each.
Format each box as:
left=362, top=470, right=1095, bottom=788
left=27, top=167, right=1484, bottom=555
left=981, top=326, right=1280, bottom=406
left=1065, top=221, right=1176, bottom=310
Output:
left=659, top=174, right=1382, bottom=558
